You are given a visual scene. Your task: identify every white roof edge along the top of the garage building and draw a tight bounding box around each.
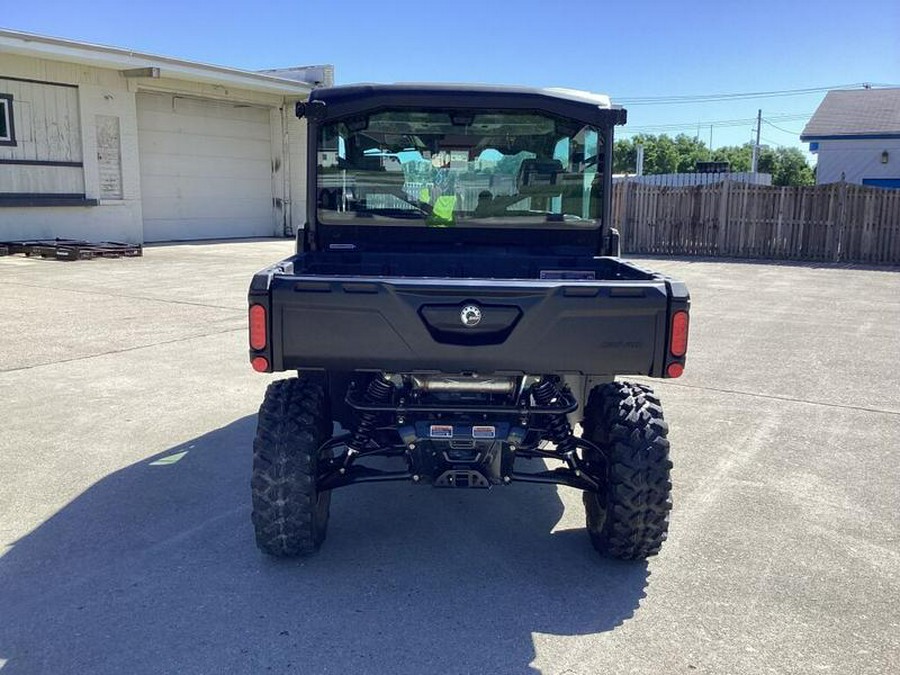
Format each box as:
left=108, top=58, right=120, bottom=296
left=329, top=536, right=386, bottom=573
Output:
left=0, top=28, right=313, bottom=98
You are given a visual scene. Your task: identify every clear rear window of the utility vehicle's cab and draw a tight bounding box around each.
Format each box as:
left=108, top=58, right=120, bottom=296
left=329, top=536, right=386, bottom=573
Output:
left=317, top=110, right=603, bottom=229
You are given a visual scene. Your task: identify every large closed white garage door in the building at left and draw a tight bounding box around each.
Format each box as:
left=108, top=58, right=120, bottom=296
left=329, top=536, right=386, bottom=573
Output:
left=137, top=93, right=275, bottom=241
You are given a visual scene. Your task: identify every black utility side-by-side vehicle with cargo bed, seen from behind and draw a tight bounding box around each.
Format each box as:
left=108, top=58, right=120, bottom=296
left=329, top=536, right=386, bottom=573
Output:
left=249, top=85, right=689, bottom=559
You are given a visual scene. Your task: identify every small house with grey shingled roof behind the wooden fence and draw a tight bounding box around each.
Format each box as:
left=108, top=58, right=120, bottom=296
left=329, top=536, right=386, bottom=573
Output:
left=800, top=89, right=900, bottom=188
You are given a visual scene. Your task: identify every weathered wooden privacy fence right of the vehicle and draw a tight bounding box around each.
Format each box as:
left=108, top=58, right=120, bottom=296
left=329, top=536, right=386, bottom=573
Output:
left=613, top=181, right=900, bottom=264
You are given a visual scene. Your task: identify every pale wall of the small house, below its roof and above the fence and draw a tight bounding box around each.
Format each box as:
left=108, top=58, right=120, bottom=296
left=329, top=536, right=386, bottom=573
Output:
left=816, top=138, right=900, bottom=185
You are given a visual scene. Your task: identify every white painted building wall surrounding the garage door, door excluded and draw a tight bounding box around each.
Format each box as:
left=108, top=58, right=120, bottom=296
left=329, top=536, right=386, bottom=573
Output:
left=0, top=53, right=306, bottom=242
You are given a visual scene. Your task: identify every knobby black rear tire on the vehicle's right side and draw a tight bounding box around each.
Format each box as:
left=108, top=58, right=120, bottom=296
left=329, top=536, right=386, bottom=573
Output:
left=583, top=382, right=672, bottom=560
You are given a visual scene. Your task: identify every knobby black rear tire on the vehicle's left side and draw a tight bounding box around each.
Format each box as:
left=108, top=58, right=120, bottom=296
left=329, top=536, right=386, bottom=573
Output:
left=250, top=378, right=332, bottom=557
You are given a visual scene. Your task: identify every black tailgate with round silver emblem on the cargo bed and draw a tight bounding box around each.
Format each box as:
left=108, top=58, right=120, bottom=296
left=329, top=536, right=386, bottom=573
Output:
left=251, top=274, right=669, bottom=376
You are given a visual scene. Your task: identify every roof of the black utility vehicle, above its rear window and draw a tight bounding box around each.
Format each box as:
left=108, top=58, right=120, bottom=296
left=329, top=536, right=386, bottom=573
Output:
left=310, top=82, right=626, bottom=124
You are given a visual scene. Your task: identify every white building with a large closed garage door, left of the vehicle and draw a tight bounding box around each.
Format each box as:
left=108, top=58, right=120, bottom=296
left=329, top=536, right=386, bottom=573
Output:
left=0, top=30, right=333, bottom=242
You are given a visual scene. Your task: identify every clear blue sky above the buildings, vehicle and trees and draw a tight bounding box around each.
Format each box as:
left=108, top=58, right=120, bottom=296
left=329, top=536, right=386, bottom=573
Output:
left=0, top=0, right=900, bottom=156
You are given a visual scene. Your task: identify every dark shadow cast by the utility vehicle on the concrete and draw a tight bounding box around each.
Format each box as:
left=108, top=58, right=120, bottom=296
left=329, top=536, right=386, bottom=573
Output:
left=0, top=416, right=649, bottom=675
